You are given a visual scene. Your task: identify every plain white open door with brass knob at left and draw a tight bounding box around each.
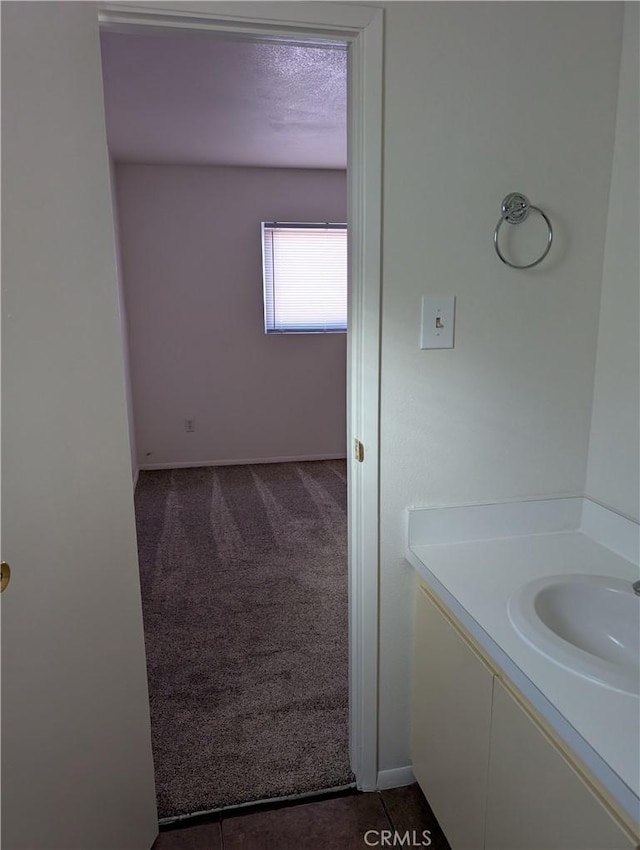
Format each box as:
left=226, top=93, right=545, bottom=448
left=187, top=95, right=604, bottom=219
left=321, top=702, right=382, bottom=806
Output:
left=2, top=2, right=157, bottom=850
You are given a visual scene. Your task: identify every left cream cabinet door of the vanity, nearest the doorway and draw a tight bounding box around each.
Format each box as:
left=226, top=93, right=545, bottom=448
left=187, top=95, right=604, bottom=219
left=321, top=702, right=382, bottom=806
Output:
left=411, top=588, right=494, bottom=850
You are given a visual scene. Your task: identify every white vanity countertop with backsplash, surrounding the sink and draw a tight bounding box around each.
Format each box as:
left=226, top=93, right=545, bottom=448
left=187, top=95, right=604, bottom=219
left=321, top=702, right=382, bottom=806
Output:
left=406, top=499, right=640, bottom=820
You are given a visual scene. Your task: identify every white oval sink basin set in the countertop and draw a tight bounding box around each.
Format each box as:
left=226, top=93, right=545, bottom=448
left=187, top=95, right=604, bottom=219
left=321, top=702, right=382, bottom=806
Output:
left=507, top=575, right=640, bottom=696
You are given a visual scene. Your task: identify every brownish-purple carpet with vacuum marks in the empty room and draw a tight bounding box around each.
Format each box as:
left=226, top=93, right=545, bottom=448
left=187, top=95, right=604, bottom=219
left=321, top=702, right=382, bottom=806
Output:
left=135, top=461, right=353, bottom=818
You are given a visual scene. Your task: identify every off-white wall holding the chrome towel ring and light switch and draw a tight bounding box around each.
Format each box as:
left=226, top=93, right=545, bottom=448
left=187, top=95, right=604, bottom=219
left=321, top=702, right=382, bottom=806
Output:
left=379, top=2, right=622, bottom=770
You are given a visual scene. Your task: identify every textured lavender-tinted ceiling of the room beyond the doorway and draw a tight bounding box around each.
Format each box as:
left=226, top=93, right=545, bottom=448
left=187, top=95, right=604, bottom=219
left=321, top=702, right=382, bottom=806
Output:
left=101, top=32, right=347, bottom=168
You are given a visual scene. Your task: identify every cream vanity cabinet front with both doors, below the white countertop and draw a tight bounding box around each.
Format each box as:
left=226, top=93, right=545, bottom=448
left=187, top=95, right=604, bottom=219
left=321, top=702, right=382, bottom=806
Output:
left=411, top=586, right=638, bottom=850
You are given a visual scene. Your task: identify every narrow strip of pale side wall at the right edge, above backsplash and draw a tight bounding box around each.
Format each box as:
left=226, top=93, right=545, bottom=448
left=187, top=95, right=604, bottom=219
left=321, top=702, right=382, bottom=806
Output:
left=587, top=3, right=640, bottom=520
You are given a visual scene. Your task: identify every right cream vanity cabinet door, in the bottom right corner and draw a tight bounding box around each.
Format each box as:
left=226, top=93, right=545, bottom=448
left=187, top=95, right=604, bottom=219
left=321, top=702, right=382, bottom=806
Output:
left=488, top=679, right=636, bottom=850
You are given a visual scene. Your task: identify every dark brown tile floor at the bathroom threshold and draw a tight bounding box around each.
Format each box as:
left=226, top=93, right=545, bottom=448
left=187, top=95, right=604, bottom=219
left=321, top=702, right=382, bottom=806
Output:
left=153, top=784, right=450, bottom=850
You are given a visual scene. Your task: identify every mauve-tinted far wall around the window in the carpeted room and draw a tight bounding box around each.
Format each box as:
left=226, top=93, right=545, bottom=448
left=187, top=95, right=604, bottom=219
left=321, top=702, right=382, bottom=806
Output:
left=116, top=164, right=346, bottom=466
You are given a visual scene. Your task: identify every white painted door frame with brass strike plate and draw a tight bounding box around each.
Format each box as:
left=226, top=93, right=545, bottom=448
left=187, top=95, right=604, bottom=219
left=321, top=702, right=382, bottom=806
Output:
left=97, top=0, right=384, bottom=791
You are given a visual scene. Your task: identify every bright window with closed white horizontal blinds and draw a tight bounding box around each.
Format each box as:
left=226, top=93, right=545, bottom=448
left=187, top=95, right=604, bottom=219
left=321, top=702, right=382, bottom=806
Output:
left=262, top=221, right=347, bottom=333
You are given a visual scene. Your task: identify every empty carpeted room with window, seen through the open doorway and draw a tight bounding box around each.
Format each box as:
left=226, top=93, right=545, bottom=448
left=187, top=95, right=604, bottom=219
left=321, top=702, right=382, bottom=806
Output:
left=101, top=32, right=354, bottom=821
